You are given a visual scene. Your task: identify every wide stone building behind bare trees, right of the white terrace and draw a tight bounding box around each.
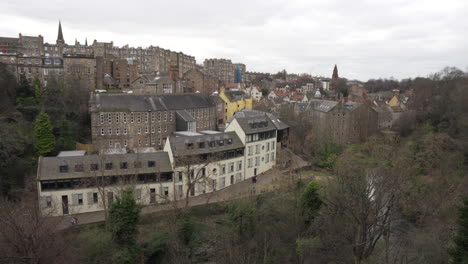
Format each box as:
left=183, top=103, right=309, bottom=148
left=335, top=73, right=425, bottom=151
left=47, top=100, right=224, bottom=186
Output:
left=304, top=99, right=378, bottom=144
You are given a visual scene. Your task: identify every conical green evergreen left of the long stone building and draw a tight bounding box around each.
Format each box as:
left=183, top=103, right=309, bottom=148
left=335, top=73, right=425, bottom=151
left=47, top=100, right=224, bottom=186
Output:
left=34, top=112, right=55, bottom=156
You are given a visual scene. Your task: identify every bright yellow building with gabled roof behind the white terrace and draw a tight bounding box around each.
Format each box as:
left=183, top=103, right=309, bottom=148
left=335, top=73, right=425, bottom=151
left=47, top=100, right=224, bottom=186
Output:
left=219, top=89, right=253, bottom=120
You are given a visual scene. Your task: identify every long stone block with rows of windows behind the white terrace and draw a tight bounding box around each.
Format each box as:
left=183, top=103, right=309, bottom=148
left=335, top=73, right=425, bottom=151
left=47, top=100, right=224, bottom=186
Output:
left=89, top=94, right=217, bottom=150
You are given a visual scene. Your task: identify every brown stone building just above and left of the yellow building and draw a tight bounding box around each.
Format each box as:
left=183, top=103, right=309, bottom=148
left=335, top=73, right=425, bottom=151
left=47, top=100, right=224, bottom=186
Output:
left=183, top=68, right=221, bottom=94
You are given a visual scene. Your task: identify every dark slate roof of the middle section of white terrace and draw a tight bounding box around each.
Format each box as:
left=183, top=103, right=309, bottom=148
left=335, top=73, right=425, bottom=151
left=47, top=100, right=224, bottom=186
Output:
left=169, top=131, right=244, bottom=157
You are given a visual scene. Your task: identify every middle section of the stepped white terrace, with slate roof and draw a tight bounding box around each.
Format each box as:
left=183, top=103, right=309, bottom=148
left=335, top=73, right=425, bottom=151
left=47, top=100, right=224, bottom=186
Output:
left=164, top=131, right=246, bottom=197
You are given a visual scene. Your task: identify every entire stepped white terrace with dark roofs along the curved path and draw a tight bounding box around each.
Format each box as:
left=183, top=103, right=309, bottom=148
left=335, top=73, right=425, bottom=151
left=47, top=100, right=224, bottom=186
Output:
left=37, top=110, right=288, bottom=216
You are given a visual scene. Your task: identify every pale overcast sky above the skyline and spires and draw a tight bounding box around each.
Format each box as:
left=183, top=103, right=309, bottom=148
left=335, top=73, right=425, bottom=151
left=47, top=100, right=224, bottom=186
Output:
left=0, top=0, right=468, bottom=80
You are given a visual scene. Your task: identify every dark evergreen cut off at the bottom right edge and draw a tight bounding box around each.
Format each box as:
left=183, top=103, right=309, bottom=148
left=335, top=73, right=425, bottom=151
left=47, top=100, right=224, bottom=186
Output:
left=449, top=196, right=468, bottom=264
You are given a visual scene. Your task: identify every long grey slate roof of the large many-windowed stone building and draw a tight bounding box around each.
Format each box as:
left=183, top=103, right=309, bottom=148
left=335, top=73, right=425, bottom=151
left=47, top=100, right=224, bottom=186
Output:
left=90, top=93, right=215, bottom=112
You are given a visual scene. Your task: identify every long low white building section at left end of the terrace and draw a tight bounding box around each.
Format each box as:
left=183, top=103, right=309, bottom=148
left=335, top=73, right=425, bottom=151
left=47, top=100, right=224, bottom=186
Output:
left=37, top=151, right=175, bottom=216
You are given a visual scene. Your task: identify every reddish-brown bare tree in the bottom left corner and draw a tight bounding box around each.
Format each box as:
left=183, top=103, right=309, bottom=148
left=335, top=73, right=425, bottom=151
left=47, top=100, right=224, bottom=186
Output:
left=0, top=195, right=73, bottom=263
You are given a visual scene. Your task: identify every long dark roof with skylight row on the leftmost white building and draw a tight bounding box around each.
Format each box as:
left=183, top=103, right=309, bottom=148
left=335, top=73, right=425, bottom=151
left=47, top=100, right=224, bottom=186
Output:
left=37, top=152, right=172, bottom=180
